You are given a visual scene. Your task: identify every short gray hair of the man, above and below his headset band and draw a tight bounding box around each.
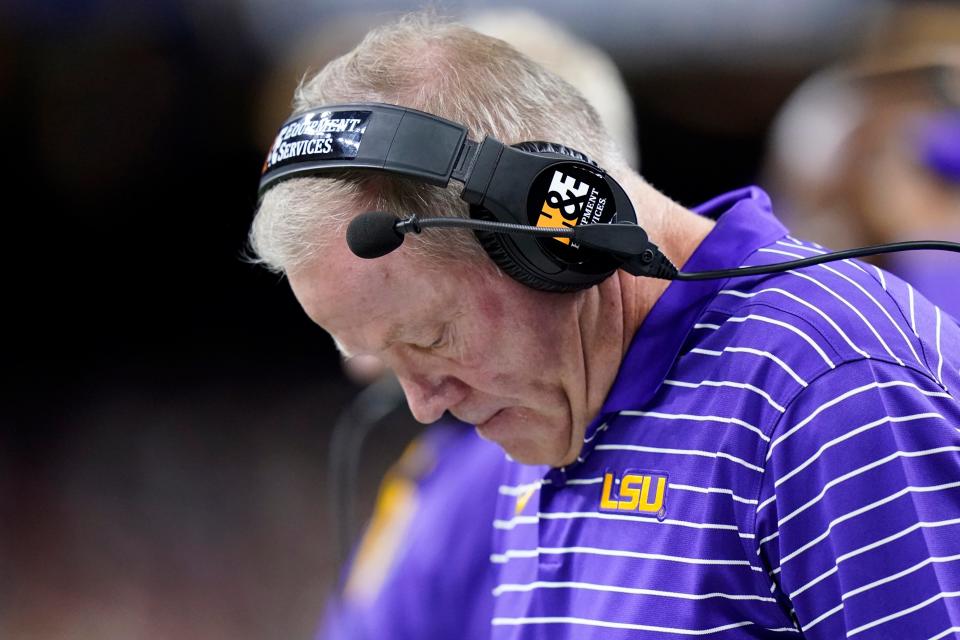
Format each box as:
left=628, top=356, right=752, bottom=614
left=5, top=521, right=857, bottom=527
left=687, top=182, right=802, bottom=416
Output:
left=250, top=13, right=626, bottom=272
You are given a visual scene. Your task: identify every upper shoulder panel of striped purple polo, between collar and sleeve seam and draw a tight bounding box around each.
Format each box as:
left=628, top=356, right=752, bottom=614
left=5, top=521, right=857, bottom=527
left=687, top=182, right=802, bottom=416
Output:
left=688, top=237, right=960, bottom=396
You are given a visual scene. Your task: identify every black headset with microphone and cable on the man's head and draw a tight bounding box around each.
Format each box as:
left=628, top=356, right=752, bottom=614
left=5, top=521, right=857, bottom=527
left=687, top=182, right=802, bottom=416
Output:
left=259, top=103, right=960, bottom=292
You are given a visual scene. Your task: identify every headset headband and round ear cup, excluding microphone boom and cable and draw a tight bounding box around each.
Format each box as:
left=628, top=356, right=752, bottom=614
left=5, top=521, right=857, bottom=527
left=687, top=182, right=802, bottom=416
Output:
left=259, top=103, right=636, bottom=291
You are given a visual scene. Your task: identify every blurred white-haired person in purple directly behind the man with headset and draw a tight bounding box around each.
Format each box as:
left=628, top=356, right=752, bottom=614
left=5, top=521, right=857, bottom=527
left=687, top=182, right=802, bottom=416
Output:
left=318, top=10, right=639, bottom=640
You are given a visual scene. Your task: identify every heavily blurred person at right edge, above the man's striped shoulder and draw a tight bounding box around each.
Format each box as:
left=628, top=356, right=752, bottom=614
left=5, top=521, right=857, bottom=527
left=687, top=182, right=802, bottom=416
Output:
left=767, top=3, right=960, bottom=317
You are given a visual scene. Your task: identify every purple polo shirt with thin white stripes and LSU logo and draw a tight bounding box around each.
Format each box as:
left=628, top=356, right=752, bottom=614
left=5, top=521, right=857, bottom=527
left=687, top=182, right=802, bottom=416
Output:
left=490, top=188, right=960, bottom=640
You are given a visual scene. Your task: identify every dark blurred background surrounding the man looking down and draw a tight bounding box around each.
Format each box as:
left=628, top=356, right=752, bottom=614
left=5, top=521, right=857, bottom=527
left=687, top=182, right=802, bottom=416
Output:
left=0, top=0, right=960, bottom=640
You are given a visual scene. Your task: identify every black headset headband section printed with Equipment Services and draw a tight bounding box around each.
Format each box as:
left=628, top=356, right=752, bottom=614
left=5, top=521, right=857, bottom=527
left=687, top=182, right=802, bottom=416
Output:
left=259, top=103, right=479, bottom=195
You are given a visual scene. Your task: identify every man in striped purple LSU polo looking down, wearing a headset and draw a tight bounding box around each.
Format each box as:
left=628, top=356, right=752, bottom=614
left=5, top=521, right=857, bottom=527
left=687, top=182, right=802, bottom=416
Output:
left=252, top=12, right=960, bottom=638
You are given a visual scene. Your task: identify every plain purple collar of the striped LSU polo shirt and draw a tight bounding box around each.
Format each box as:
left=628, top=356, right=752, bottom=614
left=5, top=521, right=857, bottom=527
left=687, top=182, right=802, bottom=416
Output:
left=564, top=187, right=787, bottom=470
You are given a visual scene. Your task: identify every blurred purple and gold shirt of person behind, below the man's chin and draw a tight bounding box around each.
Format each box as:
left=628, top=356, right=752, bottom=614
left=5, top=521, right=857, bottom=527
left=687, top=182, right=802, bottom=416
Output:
left=317, top=419, right=506, bottom=640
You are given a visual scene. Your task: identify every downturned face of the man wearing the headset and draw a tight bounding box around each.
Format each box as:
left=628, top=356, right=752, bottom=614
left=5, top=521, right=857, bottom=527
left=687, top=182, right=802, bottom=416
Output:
left=290, top=232, right=596, bottom=466
